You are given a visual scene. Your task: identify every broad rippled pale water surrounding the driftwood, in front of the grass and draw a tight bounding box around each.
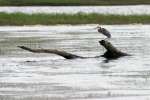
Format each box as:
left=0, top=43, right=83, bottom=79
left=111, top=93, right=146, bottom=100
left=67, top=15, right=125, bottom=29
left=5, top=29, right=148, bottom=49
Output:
left=0, top=25, right=150, bottom=100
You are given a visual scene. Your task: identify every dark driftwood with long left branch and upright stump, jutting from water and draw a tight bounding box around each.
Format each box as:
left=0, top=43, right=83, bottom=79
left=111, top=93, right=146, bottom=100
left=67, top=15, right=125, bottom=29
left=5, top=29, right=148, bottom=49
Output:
left=18, top=40, right=128, bottom=59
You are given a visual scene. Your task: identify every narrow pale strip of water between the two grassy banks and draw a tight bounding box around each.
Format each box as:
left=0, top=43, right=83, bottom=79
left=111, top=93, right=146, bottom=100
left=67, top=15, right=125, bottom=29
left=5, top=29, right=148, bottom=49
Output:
left=0, top=5, right=150, bottom=15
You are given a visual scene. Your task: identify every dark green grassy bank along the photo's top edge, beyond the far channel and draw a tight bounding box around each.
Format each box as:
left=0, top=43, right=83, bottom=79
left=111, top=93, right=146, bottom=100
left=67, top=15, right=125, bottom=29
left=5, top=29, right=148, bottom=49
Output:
left=0, top=0, right=150, bottom=6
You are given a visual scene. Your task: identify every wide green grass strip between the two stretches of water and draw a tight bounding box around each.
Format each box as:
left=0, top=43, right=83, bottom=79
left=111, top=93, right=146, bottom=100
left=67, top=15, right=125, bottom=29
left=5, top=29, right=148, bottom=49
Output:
left=0, top=13, right=150, bottom=25
